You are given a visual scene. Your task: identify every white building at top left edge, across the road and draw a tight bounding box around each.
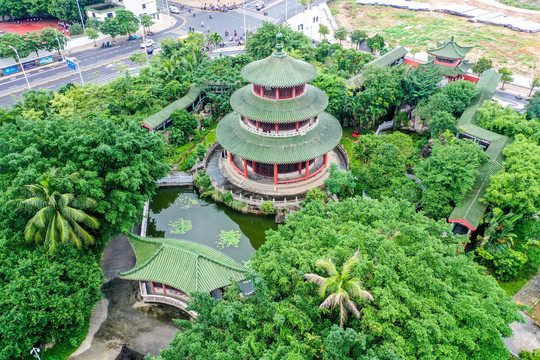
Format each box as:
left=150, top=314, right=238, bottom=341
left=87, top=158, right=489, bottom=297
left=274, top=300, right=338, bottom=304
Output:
left=84, top=0, right=158, bottom=21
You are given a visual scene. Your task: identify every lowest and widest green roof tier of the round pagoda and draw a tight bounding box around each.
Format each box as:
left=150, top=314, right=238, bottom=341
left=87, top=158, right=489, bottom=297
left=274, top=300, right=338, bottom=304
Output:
left=217, top=112, right=341, bottom=164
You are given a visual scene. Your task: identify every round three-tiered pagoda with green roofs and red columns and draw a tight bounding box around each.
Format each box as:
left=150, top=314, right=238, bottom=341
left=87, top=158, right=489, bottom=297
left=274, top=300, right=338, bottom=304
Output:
left=217, top=34, right=341, bottom=185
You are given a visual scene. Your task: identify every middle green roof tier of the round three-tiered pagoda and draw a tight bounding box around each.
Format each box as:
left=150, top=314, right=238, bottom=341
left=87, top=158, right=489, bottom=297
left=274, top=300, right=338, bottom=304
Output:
left=231, top=85, right=328, bottom=123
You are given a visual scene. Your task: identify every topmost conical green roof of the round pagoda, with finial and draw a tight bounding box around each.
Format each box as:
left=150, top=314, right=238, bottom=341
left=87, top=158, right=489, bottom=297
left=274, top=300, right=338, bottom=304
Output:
left=242, top=34, right=317, bottom=87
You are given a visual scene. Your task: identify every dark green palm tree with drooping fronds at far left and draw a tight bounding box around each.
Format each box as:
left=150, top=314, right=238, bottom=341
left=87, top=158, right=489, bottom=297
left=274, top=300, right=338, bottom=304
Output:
left=10, top=169, right=99, bottom=252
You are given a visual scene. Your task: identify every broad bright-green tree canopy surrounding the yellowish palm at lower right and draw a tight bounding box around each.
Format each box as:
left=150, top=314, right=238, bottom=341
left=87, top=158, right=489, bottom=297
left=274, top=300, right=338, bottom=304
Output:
left=161, top=198, right=519, bottom=360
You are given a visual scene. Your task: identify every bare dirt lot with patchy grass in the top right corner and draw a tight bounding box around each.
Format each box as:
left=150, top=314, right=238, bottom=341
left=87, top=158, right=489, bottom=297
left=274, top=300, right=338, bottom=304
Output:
left=330, top=0, right=540, bottom=77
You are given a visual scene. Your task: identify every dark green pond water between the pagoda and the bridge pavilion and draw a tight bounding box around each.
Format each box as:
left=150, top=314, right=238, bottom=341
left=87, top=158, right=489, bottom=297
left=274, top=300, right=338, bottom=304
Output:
left=147, top=187, right=277, bottom=264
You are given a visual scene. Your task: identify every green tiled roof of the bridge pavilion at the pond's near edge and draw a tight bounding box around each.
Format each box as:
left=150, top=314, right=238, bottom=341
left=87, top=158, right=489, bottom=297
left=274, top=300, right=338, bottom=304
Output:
left=120, top=235, right=247, bottom=294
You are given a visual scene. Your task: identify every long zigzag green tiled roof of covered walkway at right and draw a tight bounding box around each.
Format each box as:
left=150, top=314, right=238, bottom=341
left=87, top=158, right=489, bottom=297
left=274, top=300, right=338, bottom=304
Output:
left=448, top=70, right=511, bottom=230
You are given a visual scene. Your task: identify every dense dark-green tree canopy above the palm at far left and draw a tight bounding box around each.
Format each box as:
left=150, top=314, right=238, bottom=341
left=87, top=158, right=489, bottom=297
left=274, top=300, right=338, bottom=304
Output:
left=0, top=116, right=167, bottom=234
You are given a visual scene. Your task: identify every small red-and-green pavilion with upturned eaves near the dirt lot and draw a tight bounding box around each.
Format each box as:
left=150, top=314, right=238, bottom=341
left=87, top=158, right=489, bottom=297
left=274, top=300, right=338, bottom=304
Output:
left=419, top=36, right=474, bottom=82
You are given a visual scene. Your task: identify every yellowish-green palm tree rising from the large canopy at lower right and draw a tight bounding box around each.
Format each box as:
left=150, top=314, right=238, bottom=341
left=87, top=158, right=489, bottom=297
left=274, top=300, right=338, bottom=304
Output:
left=304, top=251, right=373, bottom=327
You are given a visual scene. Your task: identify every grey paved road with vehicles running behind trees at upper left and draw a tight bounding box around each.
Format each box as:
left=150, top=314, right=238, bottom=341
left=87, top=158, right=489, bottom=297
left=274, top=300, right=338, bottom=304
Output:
left=0, top=0, right=316, bottom=107
